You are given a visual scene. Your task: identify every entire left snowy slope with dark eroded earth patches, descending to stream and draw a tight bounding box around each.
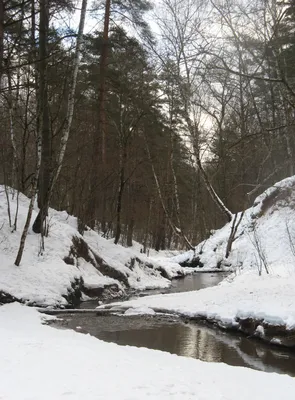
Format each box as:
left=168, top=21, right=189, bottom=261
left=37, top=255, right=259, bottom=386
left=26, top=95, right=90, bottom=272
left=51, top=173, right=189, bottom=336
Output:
left=0, top=186, right=187, bottom=306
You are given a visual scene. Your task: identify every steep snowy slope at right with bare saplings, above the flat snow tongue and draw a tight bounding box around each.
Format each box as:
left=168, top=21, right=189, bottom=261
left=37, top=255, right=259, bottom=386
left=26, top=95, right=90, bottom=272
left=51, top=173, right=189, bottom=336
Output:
left=173, top=176, right=295, bottom=276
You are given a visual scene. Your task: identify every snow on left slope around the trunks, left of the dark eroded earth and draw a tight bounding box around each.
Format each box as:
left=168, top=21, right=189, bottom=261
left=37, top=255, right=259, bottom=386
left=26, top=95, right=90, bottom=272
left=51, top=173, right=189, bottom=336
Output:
left=0, top=186, right=105, bottom=306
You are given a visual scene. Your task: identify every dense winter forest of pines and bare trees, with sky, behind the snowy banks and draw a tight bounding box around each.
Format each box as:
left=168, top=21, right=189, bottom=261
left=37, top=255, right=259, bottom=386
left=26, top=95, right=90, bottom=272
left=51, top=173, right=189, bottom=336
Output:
left=0, top=0, right=295, bottom=265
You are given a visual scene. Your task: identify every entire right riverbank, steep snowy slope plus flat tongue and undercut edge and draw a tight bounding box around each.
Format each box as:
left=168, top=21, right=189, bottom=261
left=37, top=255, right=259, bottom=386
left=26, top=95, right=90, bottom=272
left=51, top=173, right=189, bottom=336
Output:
left=95, top=176, right=295, bottom=349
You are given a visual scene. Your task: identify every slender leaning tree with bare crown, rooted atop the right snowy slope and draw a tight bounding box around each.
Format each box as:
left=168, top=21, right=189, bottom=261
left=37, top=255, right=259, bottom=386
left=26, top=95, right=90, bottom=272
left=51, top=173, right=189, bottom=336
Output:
left=153, top=0, right=232, bottom=221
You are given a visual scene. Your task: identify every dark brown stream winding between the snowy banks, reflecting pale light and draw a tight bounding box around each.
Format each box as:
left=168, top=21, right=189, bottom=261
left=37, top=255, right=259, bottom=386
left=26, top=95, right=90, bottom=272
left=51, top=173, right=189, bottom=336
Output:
left=54, top=273, right=295, bottom=376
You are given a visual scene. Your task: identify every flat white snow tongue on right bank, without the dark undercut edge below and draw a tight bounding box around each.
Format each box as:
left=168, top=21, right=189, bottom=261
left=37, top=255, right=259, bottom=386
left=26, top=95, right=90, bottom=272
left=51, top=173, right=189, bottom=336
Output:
left=102, top=272, right=295, bottom=329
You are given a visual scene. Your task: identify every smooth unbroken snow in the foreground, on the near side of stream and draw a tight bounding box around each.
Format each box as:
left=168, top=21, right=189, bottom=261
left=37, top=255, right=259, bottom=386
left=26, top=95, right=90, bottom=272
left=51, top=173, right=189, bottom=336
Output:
left=0, top=304, right=295, bottom=400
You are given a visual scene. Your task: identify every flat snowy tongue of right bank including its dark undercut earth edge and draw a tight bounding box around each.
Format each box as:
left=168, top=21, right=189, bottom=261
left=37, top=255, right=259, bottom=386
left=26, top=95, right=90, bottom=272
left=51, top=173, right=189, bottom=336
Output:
left=98, top=272, right=295, bottom=349
